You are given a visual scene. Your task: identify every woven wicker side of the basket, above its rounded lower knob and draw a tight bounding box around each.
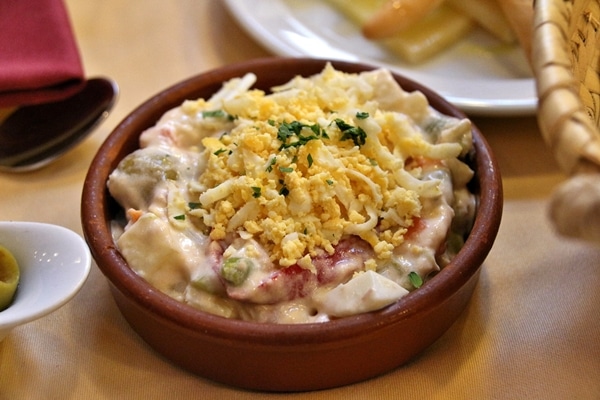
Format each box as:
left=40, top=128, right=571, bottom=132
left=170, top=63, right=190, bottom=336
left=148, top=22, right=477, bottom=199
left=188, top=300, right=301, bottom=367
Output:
left=532, top=0, right=600, bottom=170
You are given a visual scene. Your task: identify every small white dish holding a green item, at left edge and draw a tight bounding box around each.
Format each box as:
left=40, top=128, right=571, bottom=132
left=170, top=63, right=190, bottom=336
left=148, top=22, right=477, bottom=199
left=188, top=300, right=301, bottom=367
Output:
left=0, top=221, right=91, bottom=341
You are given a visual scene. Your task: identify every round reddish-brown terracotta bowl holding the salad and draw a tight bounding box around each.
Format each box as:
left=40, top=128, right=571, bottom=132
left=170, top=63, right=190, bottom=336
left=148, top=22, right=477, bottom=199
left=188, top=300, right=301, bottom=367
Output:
left=82, top=58, right=502, bottom=391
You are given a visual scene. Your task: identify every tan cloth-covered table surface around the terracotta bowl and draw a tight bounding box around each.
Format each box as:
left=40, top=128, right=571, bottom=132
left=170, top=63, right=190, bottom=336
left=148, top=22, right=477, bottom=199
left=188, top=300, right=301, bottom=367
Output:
left=0, top=0, right=600, bottom=400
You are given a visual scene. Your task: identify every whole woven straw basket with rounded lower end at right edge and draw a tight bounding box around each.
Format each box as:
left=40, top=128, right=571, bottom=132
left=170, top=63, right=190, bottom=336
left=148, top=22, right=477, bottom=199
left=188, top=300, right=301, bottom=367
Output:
left=531, top=0, right=600, bottom=243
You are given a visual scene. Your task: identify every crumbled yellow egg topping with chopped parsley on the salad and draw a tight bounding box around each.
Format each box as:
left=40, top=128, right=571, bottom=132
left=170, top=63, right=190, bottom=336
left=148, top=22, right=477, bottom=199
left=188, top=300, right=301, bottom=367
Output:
left=183, top=64, right=450, bottom=268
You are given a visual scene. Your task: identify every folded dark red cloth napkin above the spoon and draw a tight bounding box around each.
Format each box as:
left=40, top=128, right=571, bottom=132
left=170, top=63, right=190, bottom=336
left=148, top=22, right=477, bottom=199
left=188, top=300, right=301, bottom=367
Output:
left=0, top=0, right=84, bottom=107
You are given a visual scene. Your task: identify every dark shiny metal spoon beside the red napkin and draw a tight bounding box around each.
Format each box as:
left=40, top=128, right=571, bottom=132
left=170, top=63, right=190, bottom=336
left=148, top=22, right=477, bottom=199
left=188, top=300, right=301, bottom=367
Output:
left=0, top=78, right=119, bottom=172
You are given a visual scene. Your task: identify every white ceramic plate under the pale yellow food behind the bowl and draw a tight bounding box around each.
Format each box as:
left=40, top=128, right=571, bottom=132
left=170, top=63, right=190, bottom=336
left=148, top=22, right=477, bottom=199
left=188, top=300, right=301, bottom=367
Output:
left=225, top=0, right=537, bottom=116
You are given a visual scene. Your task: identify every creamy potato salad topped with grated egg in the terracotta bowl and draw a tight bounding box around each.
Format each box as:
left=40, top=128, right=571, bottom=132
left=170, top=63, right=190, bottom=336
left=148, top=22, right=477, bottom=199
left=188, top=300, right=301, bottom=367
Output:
left=107, top=64, right=476, bottom=323
